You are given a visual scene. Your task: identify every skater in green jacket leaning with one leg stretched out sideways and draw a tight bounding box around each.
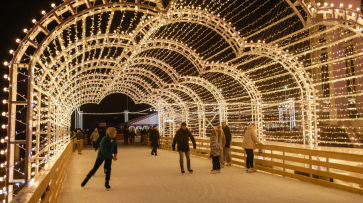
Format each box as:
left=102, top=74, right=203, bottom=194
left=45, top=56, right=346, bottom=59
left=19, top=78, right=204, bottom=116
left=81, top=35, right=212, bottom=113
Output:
left=81, top=127, right=117, bottom=189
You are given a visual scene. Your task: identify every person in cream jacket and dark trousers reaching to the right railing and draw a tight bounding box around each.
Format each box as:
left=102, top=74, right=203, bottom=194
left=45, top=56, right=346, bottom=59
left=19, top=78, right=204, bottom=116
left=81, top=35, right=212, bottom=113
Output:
left=242, top=123, right=262, bottom=173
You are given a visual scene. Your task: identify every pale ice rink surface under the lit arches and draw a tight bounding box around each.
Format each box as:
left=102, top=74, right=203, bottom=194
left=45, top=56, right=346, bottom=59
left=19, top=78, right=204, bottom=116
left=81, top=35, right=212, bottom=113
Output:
left=58, top=142, right=363, bottom=203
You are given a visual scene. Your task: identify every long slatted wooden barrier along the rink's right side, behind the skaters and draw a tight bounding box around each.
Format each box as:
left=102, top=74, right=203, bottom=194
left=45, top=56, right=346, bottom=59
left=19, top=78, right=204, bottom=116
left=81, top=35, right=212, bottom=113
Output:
left=160, top=137, right=363, bottom=194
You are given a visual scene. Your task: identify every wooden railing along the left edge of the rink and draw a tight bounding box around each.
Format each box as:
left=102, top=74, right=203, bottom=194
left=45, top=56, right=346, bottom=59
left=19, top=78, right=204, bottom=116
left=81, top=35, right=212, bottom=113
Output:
left=11, top=139, right=73, bottom=203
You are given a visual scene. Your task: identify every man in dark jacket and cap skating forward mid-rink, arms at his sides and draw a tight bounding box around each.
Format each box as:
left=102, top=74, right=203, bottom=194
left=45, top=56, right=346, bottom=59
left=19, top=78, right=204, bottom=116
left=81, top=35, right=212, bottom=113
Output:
left=172, top=122, right=197, bottom=173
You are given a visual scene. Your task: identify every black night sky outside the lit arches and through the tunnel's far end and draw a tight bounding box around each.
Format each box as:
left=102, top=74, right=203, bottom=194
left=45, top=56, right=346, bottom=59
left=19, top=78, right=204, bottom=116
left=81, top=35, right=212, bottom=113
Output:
left=0, top=0, right=151, bottom=131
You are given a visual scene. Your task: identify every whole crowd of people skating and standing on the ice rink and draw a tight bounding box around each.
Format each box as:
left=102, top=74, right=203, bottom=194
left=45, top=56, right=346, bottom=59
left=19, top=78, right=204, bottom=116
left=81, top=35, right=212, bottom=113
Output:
left=75, top=122, right=262, bottom=189
